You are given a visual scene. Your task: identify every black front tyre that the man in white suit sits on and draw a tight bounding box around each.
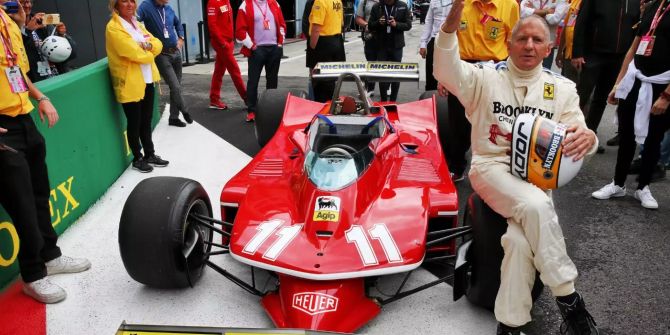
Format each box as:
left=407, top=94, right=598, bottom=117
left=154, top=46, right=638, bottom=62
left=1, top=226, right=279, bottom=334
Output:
left=463, top=193, right=544, bottom=310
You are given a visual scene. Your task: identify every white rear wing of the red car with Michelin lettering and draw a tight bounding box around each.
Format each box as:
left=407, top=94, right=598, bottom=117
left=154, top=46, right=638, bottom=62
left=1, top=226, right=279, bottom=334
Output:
left=312, top=62, right=419, bottom=84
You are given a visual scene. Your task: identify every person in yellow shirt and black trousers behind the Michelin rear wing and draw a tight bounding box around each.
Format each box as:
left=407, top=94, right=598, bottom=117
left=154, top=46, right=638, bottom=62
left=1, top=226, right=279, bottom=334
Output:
left=307, top=0, right=347, bottom=102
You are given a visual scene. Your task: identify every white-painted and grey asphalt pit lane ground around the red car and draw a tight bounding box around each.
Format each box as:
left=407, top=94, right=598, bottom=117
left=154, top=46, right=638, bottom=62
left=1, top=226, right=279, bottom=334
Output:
left=0, top=25, right=670, bottom=334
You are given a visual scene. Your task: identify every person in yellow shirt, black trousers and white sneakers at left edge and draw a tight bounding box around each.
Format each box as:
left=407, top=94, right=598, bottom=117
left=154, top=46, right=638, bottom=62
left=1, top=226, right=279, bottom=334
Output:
left=0, top=0, right=91, bottom=303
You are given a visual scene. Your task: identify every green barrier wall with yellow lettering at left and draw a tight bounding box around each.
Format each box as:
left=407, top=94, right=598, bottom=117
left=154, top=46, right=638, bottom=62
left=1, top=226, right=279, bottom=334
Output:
left=0, top=59, right=159, bottom=288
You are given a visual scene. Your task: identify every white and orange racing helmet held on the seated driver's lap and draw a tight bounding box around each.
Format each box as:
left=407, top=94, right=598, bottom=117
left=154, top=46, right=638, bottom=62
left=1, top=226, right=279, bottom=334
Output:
left=510, top=114, right=584, bottom=190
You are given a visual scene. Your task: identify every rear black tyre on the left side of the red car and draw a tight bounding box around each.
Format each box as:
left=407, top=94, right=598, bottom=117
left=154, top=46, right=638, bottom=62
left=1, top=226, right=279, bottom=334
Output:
left=254, top=89, right=307, bottom=148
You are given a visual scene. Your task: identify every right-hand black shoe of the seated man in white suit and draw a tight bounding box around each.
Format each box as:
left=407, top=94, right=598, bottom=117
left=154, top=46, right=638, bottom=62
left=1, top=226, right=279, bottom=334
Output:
left=556, top=293, right=599, bottom=335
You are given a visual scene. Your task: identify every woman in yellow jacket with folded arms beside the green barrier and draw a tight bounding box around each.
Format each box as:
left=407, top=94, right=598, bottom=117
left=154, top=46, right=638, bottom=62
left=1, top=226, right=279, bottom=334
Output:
left=105, top=0, right=170, bottom=172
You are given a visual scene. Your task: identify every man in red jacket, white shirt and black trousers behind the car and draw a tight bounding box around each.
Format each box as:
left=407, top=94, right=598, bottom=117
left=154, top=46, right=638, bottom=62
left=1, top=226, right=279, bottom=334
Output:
left=235, top=0, right=286, bottom=122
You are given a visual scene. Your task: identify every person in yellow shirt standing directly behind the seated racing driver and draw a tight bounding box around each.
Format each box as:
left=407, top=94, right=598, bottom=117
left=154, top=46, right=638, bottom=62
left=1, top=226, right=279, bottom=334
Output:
left=433, top=0, right=520, bottom=181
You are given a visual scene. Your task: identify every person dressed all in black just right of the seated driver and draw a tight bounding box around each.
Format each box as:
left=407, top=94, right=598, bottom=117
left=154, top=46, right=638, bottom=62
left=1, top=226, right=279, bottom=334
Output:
left=572, top=0, right=640, bottom=153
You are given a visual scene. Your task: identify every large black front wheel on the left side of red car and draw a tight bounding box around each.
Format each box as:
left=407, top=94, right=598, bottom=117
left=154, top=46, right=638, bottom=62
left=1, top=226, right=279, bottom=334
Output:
left=119, top=177, right=212, bottom=288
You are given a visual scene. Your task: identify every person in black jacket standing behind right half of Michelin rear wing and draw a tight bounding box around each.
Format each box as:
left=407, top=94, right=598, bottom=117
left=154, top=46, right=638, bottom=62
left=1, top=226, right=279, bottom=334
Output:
left=368, top=0, right=412, bottom=101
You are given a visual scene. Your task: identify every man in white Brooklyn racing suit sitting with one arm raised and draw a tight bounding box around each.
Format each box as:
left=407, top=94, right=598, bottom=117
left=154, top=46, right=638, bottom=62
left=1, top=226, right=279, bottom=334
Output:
left=434, top=0, right=598, bottom=334
